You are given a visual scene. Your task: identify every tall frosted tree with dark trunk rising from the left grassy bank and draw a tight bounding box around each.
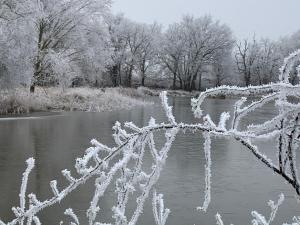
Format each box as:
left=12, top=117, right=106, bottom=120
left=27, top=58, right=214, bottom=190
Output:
left=3, top=0, right=110, bottom=92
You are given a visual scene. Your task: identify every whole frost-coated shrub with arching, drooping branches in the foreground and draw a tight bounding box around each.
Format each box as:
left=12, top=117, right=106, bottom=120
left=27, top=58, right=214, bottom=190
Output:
left=0, top=51, right=300, bottom=225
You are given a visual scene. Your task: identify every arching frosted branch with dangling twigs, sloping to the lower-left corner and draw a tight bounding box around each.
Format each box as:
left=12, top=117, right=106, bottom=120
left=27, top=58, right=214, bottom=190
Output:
left=2, top=93, right=219, bottom=225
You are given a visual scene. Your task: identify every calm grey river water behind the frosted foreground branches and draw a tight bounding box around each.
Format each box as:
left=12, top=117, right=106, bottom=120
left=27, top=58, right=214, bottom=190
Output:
left=0, top=97, right=300, bottom=225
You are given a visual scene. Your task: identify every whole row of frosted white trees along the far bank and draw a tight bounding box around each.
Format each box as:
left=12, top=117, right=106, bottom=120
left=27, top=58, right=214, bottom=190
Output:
left=0, top=0, right=300, bottom=92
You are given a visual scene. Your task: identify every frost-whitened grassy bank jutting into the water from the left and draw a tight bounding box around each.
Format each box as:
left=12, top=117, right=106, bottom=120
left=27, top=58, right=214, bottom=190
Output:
left=0, top=87, right=152, bottom=115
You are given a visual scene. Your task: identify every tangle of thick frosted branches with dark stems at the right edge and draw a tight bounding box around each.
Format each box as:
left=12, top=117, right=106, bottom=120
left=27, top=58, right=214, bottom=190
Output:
left=192, top=50, right=300, bottom=195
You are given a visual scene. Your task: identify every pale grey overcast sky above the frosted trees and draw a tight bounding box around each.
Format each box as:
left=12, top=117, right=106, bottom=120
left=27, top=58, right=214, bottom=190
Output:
left=113, top=0, right=300, bottom=39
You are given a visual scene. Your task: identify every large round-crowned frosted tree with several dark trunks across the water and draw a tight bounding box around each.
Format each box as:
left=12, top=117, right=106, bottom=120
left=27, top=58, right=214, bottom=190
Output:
left=163, top=16, right=233, bottom=91
